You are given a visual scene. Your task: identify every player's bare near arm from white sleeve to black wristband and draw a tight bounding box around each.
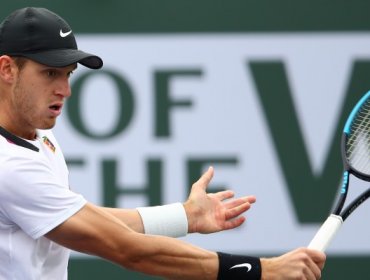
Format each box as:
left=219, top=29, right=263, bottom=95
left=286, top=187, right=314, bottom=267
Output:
left=46, top=204, right=218, bottom=280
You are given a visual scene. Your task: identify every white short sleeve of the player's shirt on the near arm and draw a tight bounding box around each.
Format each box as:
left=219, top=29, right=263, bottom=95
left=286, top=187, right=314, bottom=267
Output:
left=0, top=155, right=86, bottom=239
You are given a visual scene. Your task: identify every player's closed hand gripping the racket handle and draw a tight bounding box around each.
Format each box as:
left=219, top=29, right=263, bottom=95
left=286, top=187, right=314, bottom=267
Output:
left=261, top=248, right=326, bottom=280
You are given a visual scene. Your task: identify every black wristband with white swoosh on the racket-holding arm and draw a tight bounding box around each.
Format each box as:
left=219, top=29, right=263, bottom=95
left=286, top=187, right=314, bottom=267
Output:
left=217, top=252, right=262, bottom=280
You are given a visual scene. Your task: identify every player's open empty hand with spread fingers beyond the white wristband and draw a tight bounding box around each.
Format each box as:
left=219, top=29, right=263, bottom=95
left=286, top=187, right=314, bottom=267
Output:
left=184, top=167, right=256, bottom=233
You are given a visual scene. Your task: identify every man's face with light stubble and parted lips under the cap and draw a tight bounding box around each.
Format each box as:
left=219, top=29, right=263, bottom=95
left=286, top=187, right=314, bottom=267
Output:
left=10, top=60, right=76, bottom=135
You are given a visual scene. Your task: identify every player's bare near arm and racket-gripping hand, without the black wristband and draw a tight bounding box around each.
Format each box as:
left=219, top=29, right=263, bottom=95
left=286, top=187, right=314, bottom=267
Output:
left=46, top=204, right=325, bottom=280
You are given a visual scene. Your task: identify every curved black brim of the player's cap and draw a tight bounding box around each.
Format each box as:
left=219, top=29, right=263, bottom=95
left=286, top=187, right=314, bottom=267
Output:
left=22, top=49, right=103, bottom=69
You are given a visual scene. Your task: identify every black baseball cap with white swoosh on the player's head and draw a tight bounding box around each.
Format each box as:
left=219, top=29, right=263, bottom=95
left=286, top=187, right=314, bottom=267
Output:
left=0, top=7, right=103, bottom=69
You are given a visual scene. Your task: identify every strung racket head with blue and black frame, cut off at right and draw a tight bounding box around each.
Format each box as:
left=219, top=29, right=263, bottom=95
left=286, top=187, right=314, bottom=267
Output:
left=342, top=91, right=370, bottom=181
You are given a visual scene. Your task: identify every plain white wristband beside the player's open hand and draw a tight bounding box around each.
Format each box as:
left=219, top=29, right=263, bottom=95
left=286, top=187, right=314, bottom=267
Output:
left=136, top=203, right=188, bottom=237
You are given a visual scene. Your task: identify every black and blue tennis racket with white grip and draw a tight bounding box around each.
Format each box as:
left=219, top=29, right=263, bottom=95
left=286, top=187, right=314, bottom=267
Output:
left=308, top=91, right=370, bottom=252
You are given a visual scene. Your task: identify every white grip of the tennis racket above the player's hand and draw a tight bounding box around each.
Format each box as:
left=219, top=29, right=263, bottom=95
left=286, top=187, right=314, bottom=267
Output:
left=308, top=214, right=343, bottom=252
